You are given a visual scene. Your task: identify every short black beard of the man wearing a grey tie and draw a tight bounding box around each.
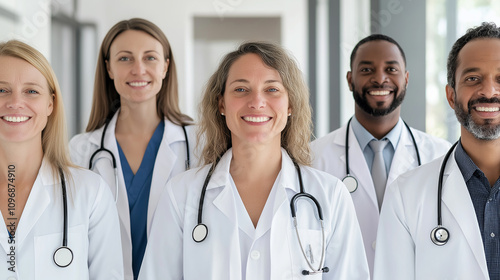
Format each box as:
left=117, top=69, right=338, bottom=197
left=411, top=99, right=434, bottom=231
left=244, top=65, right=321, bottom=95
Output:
left=351, top=83, right=406, bottom=117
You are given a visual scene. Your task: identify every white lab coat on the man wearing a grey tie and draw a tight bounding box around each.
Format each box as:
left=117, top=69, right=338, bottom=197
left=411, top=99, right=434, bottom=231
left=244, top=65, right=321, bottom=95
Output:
left=311, top=119, right=451, bottom=273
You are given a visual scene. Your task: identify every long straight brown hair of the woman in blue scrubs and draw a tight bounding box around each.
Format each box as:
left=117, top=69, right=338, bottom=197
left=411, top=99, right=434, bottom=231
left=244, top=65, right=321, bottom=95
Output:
left=86, top=18, right=192, bottom=132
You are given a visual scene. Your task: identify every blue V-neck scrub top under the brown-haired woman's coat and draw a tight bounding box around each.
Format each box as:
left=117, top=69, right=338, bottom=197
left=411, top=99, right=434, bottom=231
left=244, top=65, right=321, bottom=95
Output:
left=116, top=121, right=165, bottom=279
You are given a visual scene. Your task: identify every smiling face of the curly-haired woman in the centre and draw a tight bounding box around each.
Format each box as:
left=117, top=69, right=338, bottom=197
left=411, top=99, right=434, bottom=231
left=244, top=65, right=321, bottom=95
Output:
left=219, top=53, right=291, bottom=147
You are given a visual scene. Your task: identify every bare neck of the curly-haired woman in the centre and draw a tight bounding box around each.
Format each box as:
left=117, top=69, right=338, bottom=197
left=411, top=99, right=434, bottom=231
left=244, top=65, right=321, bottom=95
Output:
left=229, top=142, right=281, bottom=179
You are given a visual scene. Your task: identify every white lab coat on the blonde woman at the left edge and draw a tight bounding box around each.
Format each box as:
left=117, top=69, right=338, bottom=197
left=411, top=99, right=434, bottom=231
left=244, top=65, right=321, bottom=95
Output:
left=0, top=160, right=123, bottom=280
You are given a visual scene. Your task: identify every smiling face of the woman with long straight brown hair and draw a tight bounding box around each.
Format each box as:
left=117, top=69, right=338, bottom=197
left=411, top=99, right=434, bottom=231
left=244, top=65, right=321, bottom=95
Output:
left=106, top=30, right=168, bottom=104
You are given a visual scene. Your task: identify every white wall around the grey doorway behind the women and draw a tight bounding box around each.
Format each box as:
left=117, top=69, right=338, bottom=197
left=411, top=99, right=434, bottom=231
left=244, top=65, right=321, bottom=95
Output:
left=76, top=0, right=307, bottom=119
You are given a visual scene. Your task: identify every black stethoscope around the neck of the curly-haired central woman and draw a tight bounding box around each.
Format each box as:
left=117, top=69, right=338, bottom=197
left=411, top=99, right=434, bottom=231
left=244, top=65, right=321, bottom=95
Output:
left=192, top=158, right=330, bottom=275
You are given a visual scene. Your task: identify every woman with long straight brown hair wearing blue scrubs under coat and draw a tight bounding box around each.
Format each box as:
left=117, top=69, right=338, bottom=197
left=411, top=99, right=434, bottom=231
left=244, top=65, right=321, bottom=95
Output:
left=70, top=18, right=198, bottom=280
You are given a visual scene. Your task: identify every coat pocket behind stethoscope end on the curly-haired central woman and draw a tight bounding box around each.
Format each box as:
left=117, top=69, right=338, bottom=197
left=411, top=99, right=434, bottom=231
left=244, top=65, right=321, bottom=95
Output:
left=289, top=228, right=326, bottom=279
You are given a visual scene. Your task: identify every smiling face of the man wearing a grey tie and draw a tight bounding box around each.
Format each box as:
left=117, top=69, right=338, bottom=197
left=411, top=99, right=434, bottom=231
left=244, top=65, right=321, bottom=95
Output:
left=347, top=40, right=408, bottom=117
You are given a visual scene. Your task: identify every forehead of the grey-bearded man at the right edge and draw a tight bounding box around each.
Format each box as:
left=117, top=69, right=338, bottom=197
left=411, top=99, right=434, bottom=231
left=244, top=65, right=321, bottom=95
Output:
left=457, top=38, right=500, bottom=75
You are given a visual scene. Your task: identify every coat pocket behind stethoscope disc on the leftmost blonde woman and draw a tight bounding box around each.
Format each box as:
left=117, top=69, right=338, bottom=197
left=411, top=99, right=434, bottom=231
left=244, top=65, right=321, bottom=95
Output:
left=35, top=225, right=88, bottom=280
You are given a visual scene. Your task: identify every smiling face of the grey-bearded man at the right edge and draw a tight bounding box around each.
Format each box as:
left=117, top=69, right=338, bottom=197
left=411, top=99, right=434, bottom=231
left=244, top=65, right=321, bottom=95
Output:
left=446, top=39, right=500, bottom=140
